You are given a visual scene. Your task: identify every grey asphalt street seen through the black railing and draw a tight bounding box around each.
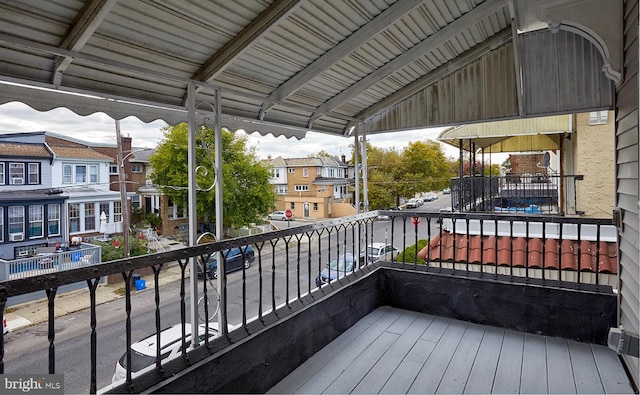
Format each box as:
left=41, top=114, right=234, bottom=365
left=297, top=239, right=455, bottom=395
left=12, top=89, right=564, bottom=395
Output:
left=4, top=200, right=450, bottom=394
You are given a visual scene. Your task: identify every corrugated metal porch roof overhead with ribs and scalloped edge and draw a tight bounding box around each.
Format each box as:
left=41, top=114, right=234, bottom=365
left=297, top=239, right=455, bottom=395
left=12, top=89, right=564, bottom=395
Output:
left=0, top=0, right=618, bottom=138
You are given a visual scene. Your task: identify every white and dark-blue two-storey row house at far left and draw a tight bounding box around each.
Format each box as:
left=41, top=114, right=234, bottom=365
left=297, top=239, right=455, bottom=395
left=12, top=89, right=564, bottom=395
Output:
left=0, top=131, right=122, bottom=259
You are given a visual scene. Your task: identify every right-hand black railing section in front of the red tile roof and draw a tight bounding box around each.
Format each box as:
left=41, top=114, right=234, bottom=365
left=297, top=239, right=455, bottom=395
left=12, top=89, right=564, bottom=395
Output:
left=380, top=211, right=618, bottom=287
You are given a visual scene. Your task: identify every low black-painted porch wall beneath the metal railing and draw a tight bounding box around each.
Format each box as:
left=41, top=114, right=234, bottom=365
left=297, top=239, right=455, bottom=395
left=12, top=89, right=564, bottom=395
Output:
left=120, top=263, right=616, bottom=393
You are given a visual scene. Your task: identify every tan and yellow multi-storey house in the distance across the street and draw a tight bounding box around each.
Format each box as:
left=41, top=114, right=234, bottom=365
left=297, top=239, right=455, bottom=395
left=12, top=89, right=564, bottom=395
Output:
left=265, top=156, right=356, bottom=218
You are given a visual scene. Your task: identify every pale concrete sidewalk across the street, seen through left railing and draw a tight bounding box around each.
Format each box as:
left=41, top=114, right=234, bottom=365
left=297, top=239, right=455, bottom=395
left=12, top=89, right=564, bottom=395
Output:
left=4, top=238, right=184, bottom=332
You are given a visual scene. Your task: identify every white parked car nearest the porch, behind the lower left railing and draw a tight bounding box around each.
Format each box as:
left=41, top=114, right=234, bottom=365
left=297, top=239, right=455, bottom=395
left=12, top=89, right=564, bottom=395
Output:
left=111, top=323, right=218, bottom=383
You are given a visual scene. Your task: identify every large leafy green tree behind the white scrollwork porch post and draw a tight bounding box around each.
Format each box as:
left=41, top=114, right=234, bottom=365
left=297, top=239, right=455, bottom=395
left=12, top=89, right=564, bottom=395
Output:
left=149, top=123, right=276, bottom=227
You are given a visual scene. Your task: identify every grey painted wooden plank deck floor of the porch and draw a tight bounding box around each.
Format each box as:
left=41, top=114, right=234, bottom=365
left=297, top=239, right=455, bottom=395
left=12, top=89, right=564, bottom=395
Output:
left=269, top=307, right=633, bottom=394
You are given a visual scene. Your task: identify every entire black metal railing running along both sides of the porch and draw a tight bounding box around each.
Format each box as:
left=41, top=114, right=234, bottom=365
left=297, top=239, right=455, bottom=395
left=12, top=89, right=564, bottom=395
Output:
left=0, top=211, right=617, bottom=393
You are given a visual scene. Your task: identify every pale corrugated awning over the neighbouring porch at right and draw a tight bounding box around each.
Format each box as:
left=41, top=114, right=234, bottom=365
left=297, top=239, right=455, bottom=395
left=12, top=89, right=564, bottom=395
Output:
left=437, top=115, right=570, bottom=153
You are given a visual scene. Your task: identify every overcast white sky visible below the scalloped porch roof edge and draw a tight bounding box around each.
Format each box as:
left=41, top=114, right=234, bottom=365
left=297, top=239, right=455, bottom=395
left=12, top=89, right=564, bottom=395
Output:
left=0, top=102, right=458, bottom=159
